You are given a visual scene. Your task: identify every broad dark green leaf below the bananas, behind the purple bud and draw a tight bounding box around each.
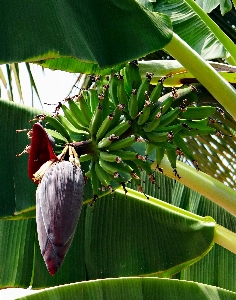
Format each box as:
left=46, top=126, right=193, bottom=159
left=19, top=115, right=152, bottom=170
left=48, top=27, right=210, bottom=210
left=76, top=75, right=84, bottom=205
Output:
left=30, top=190, right=214, bottom=288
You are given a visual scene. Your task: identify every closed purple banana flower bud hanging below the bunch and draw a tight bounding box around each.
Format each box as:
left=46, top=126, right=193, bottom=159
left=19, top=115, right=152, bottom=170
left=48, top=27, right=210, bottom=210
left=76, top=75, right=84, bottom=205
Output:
left=36, top=161, right=84, bottom=275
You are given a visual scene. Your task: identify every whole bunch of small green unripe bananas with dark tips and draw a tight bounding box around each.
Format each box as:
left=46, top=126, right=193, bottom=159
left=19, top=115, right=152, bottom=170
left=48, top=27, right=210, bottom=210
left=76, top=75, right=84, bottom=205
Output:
left=38, top=61, right=227, bottom=202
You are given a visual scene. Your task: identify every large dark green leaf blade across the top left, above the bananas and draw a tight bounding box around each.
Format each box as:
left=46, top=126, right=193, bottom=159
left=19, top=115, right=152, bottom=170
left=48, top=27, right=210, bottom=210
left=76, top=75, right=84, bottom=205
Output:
left=0, top=0, right=171, bottom=68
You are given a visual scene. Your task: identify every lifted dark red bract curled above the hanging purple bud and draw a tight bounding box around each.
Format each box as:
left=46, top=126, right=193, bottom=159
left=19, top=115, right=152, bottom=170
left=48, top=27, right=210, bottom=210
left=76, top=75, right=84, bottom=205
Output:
left=28, top=123, right=57, bottom=183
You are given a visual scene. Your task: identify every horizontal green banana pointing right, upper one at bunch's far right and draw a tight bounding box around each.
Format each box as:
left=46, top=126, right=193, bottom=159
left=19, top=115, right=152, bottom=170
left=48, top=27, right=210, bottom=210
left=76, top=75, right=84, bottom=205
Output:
left=179, top=106, right=216, bottom=120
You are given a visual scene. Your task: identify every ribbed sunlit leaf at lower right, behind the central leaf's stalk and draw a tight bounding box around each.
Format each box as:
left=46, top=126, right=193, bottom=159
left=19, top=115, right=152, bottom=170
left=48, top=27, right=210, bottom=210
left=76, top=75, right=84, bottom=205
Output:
left=132, top=171, right=236, bottom=292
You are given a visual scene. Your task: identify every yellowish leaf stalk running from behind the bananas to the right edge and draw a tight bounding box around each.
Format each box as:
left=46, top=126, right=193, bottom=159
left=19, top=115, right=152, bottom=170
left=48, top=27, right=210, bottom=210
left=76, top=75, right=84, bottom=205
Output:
left=152, top=156, right=236, bottom=215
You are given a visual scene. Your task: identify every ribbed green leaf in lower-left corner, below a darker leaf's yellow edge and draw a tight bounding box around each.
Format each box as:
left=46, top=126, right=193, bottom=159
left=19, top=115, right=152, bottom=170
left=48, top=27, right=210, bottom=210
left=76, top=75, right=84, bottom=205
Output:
left=0, top=219, right=35, bottom=288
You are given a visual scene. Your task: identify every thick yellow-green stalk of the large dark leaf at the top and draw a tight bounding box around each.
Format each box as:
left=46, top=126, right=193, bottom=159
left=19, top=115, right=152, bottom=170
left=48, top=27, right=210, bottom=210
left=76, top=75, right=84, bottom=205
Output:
left=165, top=33, right=236, bottom=119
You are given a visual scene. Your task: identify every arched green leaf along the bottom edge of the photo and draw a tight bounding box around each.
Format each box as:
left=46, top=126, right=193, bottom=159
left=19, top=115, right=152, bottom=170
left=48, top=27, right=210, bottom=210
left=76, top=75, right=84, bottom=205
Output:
left=14, top=278, right=236, bottom=300
